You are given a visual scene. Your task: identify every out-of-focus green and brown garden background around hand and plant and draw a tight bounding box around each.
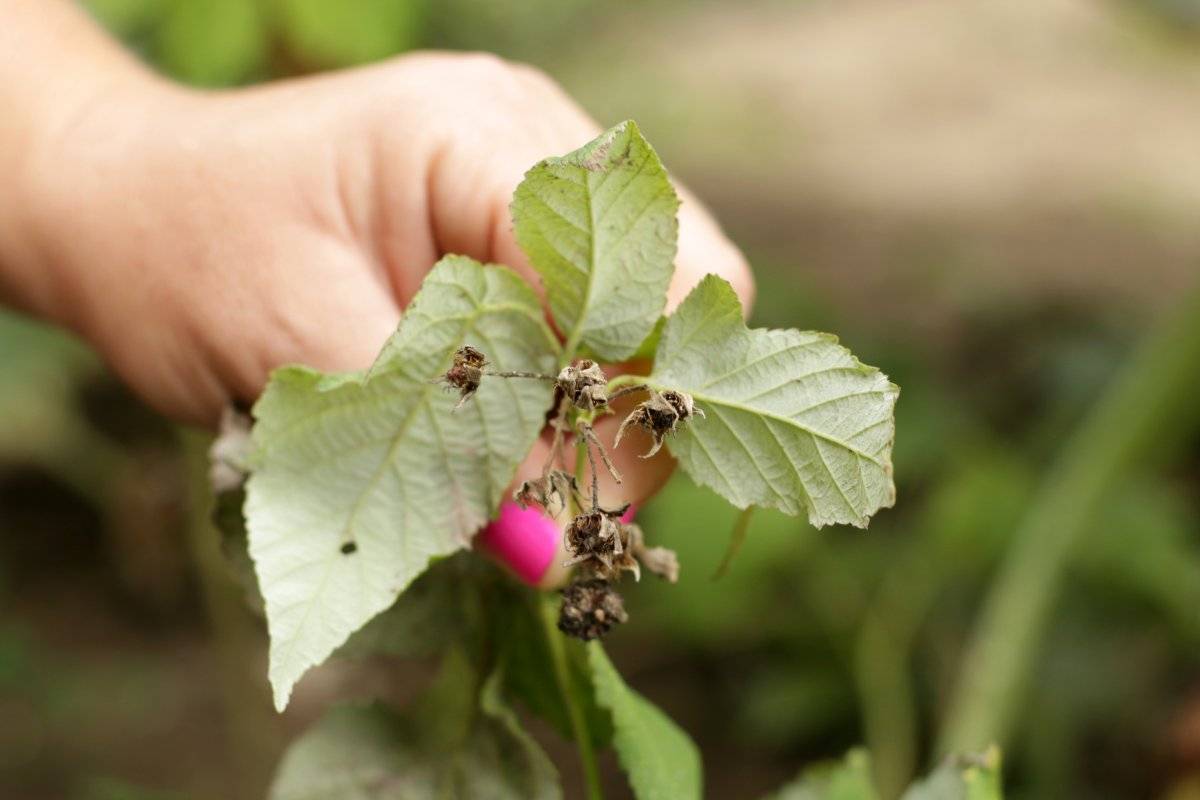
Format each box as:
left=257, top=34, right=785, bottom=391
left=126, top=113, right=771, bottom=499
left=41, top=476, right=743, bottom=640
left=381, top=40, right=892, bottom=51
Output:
left=0, top=0, right=1200, bottom=800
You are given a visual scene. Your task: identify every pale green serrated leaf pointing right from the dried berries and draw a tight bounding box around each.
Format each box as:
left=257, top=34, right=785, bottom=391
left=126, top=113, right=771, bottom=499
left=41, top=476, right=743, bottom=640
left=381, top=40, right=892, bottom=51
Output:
left=649, top=275, right=900, bottom=528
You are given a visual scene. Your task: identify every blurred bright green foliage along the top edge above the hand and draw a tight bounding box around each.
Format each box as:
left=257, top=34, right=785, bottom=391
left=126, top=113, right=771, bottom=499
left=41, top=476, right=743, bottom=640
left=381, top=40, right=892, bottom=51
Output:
left=80, top=0, right=598, bottom=86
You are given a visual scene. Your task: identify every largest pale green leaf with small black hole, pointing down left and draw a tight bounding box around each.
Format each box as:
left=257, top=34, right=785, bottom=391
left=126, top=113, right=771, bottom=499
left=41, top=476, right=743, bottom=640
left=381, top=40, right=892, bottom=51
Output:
left=246, top=257, right=557, bottom=709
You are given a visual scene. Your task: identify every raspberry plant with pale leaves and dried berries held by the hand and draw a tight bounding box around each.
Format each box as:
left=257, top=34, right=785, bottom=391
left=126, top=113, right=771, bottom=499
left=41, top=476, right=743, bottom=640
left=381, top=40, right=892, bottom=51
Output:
left=218, top=122, right=936, bottom=800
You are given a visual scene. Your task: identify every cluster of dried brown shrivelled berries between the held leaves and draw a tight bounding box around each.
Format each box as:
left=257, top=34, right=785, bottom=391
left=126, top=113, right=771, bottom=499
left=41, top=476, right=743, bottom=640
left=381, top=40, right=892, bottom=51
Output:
left=442, top=345, right=704, bottom=639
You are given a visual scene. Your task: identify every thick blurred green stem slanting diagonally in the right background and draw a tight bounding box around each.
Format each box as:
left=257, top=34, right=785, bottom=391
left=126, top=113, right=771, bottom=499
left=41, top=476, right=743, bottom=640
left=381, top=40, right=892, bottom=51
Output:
left=938, top=281, right=1200, bottom=753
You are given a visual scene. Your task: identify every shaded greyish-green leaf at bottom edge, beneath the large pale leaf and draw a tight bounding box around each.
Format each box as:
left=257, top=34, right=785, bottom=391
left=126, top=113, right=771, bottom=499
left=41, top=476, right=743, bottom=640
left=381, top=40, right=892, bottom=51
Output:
left=269, top=650, right=562, bottom=800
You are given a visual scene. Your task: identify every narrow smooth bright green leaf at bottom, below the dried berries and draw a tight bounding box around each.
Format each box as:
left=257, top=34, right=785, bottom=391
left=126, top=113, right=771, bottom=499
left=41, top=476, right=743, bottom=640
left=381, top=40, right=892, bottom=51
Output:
left=588, top=642, right=703, bottom=800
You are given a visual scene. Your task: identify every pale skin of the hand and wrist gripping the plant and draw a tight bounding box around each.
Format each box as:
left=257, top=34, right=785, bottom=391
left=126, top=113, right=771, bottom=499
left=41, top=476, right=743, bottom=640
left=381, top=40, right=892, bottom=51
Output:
left=0, top=0, right=752, bottom=556
